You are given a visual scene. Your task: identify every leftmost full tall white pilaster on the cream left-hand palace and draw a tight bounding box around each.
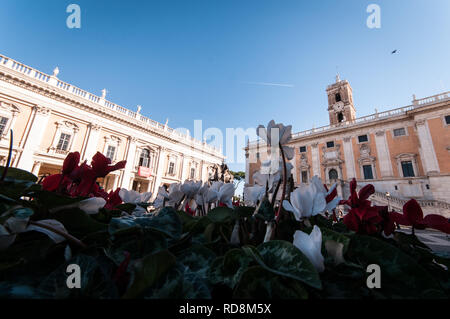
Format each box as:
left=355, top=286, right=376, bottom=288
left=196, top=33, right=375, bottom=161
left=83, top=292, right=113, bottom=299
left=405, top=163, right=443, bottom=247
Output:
left=17, top=106, right=51, bottom=171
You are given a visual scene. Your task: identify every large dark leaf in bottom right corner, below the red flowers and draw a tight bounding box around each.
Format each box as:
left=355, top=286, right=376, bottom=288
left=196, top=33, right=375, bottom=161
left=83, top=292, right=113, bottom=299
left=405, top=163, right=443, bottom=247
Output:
left=347, top=235, right=445, bottom=298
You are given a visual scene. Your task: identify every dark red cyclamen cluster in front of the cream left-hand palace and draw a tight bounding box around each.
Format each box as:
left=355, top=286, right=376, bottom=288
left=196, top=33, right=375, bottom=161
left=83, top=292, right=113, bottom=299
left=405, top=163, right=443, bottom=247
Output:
left=42, top=152, right=126, bottom=209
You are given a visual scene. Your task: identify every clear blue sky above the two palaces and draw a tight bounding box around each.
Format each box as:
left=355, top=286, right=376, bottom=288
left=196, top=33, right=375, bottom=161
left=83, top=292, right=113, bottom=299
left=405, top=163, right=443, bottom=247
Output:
left=0, top=0, right=450, bottom=175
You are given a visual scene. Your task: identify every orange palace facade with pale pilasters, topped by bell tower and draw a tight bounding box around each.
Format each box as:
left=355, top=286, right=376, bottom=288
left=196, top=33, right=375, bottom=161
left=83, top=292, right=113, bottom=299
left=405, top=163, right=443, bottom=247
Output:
left=246, top=76, right=450, bottom=217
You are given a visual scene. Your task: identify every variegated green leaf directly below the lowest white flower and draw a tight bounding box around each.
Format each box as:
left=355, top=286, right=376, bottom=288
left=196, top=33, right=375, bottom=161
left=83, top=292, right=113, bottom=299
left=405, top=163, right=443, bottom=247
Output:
left=253, top=240, right=322, bottom=289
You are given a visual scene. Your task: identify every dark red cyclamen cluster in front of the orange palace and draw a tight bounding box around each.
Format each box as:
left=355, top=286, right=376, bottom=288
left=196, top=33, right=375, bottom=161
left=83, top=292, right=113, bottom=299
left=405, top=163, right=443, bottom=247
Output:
left=340, top=179, right=450, bottom=236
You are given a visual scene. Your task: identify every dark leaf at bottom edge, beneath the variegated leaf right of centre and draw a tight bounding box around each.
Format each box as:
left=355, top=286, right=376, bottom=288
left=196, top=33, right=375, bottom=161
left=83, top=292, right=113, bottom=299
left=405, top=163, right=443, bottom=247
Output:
left=233, top=266, right=308, bottom=299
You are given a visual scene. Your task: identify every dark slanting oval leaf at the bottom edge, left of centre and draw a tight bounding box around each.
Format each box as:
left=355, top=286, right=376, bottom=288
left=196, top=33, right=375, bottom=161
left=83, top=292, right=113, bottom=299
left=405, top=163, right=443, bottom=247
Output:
left=123, top=250, right=176, bottom=299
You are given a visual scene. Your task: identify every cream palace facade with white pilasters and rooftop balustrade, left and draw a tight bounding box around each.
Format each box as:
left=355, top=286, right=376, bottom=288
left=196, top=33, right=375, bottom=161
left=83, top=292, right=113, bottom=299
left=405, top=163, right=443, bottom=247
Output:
left=0, top=55, right=224, bottom=196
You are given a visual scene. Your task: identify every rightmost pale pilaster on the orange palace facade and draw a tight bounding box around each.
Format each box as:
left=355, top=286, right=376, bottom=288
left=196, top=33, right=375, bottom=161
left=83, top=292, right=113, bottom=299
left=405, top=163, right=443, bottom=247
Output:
left=416, top=119, right=440, bottom=175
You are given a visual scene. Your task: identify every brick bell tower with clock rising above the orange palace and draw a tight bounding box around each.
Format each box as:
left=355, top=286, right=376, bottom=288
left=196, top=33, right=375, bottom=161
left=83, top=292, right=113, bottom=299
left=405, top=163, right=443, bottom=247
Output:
left=327, top=74, right=356, bottom=125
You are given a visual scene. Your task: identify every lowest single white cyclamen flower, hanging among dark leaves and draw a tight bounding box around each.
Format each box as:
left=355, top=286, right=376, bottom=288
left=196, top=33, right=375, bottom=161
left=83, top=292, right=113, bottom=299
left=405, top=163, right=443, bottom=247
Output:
left=293, top=225, right=325, bottom=272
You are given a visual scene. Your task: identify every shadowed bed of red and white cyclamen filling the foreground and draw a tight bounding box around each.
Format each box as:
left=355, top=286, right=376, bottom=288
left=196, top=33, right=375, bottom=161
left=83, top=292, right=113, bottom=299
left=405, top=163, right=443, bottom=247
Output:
left=0, top=122, right=450, bottom=299
